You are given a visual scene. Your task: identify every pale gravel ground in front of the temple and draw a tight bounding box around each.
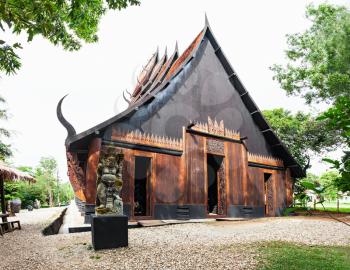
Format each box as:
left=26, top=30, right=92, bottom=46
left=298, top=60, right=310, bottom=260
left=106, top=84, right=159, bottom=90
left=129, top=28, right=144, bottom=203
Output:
left=0, top=208, right=350, bottom=270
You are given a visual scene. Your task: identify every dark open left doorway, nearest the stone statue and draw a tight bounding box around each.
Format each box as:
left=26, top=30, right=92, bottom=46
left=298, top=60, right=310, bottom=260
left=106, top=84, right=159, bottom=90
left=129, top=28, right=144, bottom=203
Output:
left=134, top=156, right=152, bottom=216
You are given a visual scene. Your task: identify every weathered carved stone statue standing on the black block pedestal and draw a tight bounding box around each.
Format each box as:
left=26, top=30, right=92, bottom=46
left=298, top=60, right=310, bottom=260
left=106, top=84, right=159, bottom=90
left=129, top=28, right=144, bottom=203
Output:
left=95, top=151, right=123, bottom=215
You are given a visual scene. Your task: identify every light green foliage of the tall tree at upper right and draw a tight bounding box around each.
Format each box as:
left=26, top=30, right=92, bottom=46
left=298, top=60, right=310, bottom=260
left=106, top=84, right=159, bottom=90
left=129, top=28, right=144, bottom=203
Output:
left=271, top=4, right=350, bottom=103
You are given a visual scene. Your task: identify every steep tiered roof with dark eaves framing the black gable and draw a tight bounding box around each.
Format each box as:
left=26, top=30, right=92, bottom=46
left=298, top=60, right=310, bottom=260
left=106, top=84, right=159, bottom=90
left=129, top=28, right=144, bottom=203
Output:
left=58, top=18, right=305, bottom=177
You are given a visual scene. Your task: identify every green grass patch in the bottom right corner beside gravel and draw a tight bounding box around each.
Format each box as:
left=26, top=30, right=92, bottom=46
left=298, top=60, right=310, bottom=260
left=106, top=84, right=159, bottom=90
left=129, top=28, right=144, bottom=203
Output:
left=258, top=242, right=350, bottom=270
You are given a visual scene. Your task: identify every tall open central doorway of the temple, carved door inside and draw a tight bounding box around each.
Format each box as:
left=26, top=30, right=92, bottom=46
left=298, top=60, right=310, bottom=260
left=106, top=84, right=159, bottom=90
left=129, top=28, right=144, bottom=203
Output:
left=207, top=154, right=226, bottom=215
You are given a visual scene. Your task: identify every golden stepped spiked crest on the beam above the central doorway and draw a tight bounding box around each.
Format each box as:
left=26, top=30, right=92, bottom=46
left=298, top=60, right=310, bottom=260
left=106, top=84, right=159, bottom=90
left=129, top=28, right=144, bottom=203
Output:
left=192, top=116, right=240, bottom=140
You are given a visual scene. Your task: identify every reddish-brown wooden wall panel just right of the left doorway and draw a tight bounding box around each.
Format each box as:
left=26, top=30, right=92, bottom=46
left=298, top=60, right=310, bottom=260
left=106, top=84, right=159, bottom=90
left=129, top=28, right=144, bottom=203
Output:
left=154, top=154, right=184, bottom=203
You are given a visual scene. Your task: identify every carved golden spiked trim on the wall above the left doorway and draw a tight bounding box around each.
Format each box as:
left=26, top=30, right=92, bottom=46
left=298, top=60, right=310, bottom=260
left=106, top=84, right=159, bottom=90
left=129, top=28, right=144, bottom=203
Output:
left=112, top=130, right=183, bottom=151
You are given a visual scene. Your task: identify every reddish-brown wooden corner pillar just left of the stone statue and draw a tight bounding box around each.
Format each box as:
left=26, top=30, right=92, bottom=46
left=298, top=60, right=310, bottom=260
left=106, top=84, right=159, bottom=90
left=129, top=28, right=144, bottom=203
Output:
left=85, top=138, right=102, bottom=223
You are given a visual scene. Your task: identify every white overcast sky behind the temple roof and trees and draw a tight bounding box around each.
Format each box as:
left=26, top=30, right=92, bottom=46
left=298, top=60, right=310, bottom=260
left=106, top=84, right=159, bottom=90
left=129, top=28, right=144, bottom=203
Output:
left=0, top=0, right=349, bottom=180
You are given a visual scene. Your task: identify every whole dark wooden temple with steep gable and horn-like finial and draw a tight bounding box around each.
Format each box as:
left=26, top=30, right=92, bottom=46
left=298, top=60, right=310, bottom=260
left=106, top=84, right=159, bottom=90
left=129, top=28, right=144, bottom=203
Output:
left=57, top=17, right=304, bottom=224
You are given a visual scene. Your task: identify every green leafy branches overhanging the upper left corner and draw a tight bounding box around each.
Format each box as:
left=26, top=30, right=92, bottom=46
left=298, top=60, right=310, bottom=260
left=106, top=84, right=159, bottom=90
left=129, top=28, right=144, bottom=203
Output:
left=0, top=0, right=140, bottom=74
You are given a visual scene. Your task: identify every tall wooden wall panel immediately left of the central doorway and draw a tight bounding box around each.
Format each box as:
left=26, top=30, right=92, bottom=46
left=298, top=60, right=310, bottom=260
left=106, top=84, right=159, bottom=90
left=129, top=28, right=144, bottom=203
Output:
left=185, top=133, right=206, bottom=204
